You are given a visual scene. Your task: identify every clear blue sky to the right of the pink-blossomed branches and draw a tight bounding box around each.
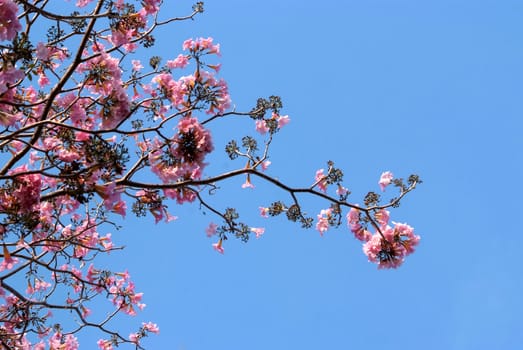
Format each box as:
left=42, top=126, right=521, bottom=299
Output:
left=83, top=0, right=523, bottom=350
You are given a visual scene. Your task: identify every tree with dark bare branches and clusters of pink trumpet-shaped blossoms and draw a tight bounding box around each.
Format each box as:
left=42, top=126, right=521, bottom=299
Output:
left=0, top=0, right=420, bottom=349
